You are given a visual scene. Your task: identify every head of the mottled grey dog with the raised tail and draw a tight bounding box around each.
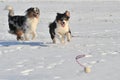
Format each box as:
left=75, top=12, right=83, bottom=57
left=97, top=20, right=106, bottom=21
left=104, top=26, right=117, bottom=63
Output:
left=26, top=7, right=40, bottom=18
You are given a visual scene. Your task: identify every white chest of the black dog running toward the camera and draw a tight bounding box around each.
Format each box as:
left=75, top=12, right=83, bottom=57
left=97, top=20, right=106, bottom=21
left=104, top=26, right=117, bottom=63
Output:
left=55, top=24, right=69, bottom=34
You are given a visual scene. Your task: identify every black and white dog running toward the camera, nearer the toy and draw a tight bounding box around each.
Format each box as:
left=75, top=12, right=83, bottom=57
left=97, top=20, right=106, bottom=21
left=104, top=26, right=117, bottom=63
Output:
left=49, top=11, right=71, bottom=43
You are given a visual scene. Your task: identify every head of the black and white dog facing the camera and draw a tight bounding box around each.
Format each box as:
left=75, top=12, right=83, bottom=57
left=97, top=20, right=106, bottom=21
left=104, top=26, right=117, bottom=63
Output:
left=56, top=11, right=70, bottom=27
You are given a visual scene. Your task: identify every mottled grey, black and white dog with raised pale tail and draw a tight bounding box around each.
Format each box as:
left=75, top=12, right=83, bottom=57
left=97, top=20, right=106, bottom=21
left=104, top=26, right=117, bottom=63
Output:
left=5, top=6, right=40, bottom=40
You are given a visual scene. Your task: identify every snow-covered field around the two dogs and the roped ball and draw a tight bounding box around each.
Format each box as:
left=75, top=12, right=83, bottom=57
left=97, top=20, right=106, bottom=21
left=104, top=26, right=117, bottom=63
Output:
left=0, top=0, right=120, bottom=80
